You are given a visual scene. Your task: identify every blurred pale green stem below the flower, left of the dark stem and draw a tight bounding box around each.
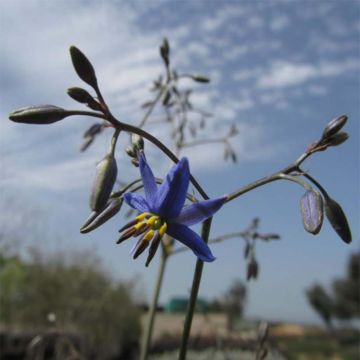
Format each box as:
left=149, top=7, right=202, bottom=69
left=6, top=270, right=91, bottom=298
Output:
left=140, top=249, right=167, bottom=360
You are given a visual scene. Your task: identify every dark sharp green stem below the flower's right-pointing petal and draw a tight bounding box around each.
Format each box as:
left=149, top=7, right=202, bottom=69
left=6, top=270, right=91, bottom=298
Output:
left=178, top=218, right=212, bottom=360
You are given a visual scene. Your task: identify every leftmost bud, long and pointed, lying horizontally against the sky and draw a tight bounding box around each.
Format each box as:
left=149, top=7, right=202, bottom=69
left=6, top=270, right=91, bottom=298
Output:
left=9, top=105, right=71, bottom=125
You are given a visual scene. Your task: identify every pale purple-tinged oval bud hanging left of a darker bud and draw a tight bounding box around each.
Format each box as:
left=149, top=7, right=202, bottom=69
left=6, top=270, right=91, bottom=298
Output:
left=300, top=190, right=324, bottom=235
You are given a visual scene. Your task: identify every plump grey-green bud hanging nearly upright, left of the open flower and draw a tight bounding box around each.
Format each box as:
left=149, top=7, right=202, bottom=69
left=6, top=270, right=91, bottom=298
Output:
left=90, top=154, right=117, bottom=212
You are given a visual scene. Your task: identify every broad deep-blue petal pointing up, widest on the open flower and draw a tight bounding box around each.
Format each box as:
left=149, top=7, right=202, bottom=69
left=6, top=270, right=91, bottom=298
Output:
left=153, top=158, right=190, bottom=219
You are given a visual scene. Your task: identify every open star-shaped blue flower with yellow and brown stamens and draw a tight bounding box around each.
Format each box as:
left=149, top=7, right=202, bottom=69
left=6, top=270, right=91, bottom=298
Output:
left=118, top=152, right=226, bottom=266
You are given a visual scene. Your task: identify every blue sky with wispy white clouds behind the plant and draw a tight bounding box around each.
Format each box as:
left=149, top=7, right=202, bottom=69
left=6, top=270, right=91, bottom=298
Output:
left=0, top=0, right=360, bottom=322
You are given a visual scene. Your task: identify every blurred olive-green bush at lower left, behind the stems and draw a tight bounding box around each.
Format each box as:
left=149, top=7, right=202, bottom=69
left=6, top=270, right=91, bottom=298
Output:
left=0, top=251, right=140, bottom=359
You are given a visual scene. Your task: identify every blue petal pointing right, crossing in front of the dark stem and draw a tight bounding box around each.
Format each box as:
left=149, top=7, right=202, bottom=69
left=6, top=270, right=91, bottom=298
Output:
left=173, top=196, right=226, bottom=226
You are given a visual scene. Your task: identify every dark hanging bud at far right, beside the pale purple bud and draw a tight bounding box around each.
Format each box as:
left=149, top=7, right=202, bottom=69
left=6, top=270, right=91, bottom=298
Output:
left=325, top=197, right=352, bottom=244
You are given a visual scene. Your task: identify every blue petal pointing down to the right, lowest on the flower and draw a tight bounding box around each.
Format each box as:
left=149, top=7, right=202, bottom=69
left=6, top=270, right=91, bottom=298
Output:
left=166, top=224, right=216, bottom=262
